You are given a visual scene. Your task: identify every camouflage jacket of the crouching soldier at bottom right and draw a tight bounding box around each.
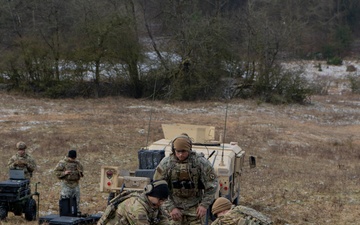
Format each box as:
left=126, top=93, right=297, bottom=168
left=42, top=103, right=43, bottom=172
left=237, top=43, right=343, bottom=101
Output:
left=211, top=205, right=272, bottom=225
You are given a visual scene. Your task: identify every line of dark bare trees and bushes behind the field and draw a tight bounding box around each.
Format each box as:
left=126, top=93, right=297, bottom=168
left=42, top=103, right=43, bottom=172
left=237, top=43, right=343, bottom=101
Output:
left=0, top=0, right=360, bottom=103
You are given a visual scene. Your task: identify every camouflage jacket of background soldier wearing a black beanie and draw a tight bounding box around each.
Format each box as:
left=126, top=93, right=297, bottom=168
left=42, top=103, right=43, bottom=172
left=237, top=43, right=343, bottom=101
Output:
left=54, top=157, right=84, bottom=188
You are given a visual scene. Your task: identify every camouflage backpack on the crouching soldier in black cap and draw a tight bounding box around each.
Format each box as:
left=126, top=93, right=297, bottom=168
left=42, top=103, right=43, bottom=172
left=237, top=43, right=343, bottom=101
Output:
left=97, top=191, right=135, bottom=225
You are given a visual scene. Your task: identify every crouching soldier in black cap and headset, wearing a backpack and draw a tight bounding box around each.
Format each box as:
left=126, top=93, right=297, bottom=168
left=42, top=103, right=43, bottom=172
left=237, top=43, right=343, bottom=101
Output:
left=97, top=180, right=169, bottom=225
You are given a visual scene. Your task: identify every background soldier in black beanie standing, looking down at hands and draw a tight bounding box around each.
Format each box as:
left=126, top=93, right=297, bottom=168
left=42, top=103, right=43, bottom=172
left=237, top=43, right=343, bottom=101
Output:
left=54, top=150, right=84, bottom=214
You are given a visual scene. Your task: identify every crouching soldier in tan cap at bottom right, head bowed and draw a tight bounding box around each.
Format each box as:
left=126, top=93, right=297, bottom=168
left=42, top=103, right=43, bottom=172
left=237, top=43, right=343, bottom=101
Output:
left=211, top=197, right=272, bottom=225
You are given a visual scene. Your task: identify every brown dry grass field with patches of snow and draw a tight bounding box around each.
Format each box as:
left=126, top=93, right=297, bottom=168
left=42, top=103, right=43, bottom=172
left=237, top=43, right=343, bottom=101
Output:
left=0, top=92, right=360, bottom=225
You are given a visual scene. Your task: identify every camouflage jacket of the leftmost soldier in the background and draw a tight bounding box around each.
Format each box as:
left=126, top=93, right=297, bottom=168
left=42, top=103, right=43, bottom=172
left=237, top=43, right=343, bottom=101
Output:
left=8, top=153, right=36, bottom=179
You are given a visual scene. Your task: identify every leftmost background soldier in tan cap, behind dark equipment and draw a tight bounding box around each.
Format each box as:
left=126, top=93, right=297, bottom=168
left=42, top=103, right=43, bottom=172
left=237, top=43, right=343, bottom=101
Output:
left=8, top=141, right=36, bottom=180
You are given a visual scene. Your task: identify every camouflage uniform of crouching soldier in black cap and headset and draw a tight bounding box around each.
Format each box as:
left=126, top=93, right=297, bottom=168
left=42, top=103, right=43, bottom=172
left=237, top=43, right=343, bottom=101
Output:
left=98, top=193, right=169, bottom=225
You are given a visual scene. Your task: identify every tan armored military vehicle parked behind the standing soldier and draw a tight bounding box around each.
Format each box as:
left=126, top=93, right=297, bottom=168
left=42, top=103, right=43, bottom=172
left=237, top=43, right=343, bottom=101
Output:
left=100, top=124, right=255, bottom=204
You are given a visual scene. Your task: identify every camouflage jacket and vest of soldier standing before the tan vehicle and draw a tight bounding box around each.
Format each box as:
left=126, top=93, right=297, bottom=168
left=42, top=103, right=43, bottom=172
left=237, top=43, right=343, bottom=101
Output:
left=154, top=151, right=218, bottom=212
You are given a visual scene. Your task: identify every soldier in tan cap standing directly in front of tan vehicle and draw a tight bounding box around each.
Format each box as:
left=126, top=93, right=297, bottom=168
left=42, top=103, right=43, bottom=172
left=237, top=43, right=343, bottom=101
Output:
left=154, top=134, right=218, bottom=225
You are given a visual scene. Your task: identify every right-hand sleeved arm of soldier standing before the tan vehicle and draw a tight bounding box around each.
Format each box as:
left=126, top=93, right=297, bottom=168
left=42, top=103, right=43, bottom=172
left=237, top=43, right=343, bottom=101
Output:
left=200, top=158, right=219, bottom=208
